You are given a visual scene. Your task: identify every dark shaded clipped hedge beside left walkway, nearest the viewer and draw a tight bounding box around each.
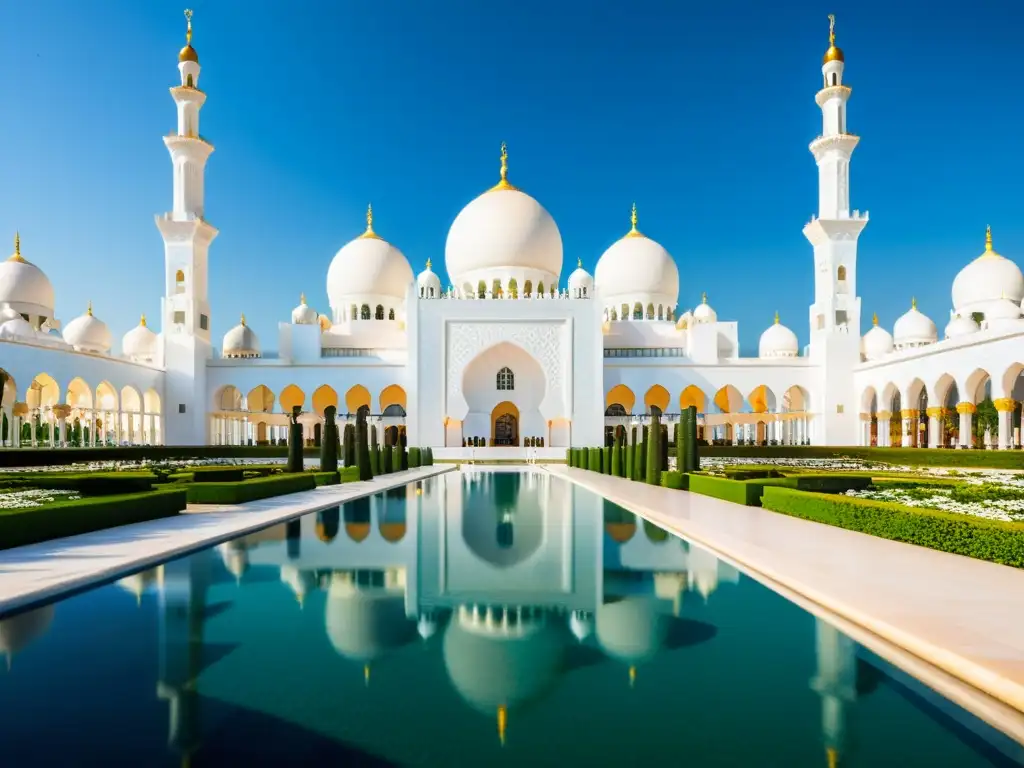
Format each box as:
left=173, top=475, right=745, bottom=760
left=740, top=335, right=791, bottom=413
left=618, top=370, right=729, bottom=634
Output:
left=0, top=487, right=186, bottom=549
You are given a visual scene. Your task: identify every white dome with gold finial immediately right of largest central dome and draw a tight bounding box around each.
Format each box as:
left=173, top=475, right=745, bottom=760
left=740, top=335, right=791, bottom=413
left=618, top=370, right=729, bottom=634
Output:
left=594, top=206, right=679, bottom=319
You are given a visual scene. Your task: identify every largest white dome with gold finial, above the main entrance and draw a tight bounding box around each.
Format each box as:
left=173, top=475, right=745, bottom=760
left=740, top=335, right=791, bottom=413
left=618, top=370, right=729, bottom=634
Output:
left=444, top=144, right=562, bottom=287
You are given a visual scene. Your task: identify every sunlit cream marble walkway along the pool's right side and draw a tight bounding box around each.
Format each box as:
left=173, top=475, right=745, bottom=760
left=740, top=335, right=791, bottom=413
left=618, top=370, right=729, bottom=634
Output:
left=546, top=465, right=1024, bottom=712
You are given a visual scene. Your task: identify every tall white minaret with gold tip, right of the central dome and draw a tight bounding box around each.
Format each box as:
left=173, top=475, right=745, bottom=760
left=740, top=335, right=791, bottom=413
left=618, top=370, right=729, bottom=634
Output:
left=804, top=15, right=867, bottom=445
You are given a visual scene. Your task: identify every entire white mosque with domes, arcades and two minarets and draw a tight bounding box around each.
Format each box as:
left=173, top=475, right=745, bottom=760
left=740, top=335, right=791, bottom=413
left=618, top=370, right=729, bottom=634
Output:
left=0, top=12, right=1024, bottom=458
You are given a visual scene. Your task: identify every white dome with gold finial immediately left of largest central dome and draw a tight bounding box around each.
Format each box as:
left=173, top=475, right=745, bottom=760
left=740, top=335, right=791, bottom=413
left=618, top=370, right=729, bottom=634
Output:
left=327, top=210, right=413, bottom=310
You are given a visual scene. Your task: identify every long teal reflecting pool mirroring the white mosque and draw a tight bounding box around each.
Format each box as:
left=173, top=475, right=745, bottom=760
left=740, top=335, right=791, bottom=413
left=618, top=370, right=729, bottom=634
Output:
left=0, top=472, right=1024, bottom=768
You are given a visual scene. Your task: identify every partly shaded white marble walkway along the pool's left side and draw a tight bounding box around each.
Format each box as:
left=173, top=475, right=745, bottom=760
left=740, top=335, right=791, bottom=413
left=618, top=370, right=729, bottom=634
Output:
left=0, top=464, right=457, bottom=614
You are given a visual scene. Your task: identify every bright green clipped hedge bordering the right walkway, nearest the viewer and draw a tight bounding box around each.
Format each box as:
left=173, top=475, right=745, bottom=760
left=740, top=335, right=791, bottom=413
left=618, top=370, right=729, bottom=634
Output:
left=762, top=486, right=1024, bottom=568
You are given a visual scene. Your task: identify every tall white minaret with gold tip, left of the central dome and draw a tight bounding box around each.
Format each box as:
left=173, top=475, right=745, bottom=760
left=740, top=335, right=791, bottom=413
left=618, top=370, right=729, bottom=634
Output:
left=157, top=10, right=217, bottom=445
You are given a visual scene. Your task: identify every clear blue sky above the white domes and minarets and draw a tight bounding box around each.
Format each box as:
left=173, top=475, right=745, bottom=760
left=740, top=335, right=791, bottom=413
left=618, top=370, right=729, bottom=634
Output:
left=0, top=0, right=1024, bottom=354
